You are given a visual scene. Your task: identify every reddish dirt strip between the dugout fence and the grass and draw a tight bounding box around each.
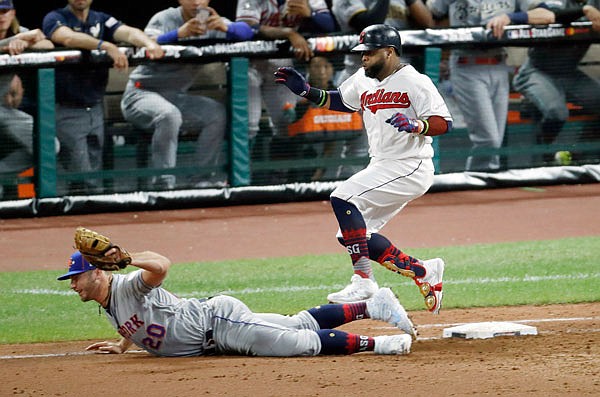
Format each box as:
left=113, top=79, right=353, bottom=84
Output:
left=0, top=184, right=600, bottom=271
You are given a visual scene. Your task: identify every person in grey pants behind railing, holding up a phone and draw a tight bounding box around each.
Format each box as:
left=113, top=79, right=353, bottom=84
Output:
left=121, top=0, right=252, bottom=189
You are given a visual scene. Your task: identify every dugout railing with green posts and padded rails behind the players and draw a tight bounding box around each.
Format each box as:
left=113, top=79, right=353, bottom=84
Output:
left=0, top=23, right=600, bottom=216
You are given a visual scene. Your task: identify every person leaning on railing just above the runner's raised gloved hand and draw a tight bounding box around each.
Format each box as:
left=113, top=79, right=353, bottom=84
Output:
left=236, top=0, right=335, bottom=138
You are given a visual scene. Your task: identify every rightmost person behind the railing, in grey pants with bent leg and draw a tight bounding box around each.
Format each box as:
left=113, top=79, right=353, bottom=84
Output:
left=513, top=0, right=600, bottom=164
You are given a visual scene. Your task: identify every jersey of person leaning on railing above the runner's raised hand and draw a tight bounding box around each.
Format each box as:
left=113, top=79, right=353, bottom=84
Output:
left=236, top=0, right=329, bottom=28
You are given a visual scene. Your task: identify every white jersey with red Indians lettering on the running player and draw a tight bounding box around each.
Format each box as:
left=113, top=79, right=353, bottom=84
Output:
left=339, top=65, right=452, bottom=159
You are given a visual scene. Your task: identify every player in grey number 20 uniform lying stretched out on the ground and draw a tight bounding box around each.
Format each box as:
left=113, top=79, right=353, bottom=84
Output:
left=58, top=248, right=416, bottom=357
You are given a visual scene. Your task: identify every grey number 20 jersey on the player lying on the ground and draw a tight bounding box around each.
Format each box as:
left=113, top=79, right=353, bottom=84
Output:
left=106, top=270, right=211, bottom=356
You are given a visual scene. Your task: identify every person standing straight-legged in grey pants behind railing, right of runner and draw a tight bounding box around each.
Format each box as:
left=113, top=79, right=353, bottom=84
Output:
left=427, top=0, right=552, bottom=172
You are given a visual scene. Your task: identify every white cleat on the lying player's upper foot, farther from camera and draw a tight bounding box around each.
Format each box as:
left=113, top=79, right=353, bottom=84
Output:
left=367, top=288, right=417, bottom=340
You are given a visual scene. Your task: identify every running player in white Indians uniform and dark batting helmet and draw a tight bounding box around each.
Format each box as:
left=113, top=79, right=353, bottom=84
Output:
left=275, top=24, right=452, bottom=313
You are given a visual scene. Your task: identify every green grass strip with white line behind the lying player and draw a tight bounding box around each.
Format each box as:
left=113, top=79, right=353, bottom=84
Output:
left=0, top=237, right=600, bottom=344
